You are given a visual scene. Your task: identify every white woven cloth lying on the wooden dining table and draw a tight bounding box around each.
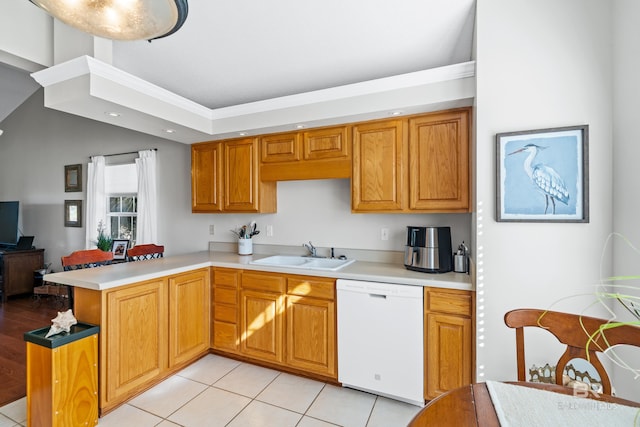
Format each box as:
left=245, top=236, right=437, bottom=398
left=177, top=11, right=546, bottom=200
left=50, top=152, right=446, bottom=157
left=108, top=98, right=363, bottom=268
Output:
left=487, top=381, right=640, bottom=427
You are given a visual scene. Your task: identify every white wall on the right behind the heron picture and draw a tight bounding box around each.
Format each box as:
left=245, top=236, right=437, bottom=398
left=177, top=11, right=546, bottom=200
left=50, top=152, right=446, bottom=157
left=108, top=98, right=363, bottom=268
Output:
left=474, top=0, right=616, bottom=394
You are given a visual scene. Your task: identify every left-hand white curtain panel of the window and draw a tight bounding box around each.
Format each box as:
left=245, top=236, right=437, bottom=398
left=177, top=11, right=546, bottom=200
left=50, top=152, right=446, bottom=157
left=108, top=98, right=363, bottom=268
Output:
left=85, top=156, right=105, bottom=249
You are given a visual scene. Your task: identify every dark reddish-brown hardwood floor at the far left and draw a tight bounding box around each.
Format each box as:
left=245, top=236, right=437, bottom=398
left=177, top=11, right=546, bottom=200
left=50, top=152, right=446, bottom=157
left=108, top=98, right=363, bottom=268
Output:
left=0, top=295, right=67, bottom=406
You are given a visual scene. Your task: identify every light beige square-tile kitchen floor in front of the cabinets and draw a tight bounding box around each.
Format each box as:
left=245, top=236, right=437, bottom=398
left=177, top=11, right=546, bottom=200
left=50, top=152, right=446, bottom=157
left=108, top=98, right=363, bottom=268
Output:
left=0, top=355, right=421, bottom=427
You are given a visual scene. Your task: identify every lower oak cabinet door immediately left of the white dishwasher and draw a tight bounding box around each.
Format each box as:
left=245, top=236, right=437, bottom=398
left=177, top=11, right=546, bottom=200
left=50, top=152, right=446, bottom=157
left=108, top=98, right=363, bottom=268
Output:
left=286, top=296, right=337, bottom=379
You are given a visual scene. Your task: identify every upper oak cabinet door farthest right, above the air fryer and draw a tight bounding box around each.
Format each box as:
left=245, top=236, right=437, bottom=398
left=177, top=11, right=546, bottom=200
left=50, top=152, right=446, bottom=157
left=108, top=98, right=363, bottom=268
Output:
left=409, top=109, right=469, bottom=212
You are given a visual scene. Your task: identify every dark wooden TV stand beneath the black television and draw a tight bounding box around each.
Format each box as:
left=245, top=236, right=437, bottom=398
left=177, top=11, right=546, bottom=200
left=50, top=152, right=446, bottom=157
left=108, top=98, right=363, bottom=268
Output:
left=0, top=249, right=44, bottom=302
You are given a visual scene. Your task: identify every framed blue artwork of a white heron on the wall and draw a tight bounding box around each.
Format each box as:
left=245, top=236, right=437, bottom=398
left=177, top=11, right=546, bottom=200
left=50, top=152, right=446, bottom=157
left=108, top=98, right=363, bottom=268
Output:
left=496, top=125, right=589, bottom=222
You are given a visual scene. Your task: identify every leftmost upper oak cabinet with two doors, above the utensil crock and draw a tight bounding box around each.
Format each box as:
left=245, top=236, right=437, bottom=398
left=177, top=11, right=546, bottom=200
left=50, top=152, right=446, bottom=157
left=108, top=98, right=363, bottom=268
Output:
left=191, top=138, right=276, bottom=213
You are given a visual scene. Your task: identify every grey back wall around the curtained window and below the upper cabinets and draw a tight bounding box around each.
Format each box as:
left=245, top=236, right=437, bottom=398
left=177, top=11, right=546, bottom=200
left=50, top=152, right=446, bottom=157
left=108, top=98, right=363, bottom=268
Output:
left=0, top=90, right=471, bottom=269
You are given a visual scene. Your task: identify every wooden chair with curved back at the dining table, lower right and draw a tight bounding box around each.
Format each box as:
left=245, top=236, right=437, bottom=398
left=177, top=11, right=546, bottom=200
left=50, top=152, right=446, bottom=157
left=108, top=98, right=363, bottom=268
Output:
left=504, top=308, right=640, bottom=394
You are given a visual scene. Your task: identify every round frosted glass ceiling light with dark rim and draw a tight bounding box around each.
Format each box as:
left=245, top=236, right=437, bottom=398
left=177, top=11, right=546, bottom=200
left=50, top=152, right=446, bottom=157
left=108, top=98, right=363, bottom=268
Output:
left=30, top=0, right=189, bottom=40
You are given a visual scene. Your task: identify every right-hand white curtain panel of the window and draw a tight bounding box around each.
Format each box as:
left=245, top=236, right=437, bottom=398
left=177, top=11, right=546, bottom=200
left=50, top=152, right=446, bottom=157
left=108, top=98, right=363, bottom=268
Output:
left=136, top=150, right=158, bottom=244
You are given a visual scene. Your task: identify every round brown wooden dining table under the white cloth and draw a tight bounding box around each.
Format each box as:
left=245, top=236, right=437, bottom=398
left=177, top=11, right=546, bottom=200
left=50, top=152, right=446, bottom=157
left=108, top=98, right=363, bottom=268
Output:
left=409, top=382, right=640, bottom=427
